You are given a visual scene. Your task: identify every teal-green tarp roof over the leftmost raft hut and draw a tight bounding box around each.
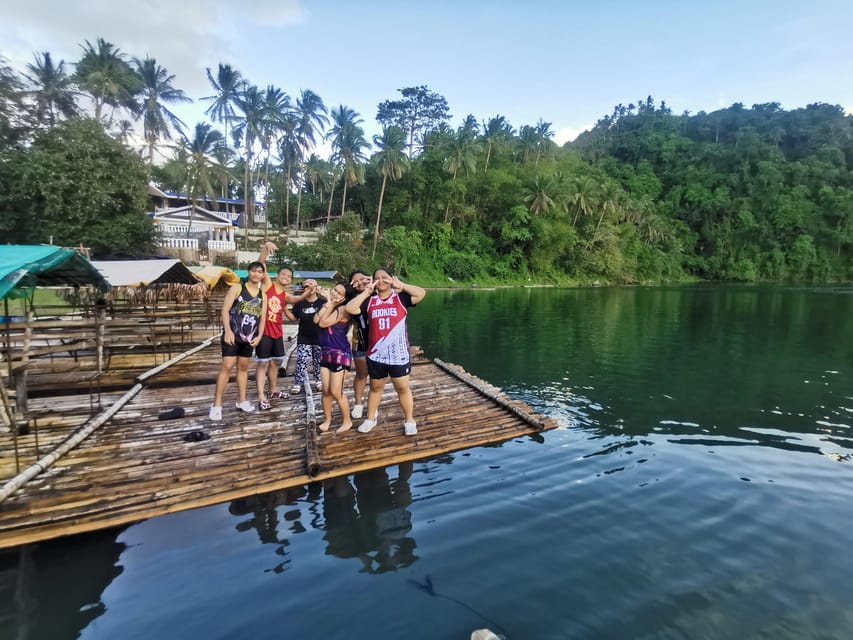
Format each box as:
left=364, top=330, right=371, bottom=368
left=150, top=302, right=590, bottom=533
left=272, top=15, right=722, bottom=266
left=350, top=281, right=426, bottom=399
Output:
left=0, top=244, right=110, bottom=300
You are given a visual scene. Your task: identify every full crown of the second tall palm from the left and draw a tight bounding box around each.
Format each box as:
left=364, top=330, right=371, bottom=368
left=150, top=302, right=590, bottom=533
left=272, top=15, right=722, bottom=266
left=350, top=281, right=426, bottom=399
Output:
left=74, top=38, right=141, bottom=120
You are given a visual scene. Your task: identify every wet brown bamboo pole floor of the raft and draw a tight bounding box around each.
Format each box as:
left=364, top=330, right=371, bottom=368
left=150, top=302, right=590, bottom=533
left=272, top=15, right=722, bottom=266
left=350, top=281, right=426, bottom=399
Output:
left=0, top=344, right=556, bottom=548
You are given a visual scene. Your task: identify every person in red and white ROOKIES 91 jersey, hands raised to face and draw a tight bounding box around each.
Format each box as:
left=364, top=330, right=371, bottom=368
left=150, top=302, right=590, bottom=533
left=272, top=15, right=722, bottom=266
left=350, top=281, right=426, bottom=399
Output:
left=346, top=269, right=426, bottom=436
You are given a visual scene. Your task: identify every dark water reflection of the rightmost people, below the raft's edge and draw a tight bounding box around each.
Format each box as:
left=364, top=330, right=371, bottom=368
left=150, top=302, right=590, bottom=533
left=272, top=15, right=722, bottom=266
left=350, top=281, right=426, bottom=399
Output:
left=323, top=462, right=417, bottom=573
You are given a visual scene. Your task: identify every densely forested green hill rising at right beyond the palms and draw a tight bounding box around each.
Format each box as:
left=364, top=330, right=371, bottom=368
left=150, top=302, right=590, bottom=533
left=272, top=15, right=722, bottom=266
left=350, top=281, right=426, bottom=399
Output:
left=571, top=99, right=853, bottom=281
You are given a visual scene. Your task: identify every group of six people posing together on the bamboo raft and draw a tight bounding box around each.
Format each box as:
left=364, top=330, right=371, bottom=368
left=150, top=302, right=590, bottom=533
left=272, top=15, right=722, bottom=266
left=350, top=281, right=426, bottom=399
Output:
left=209, top=242, right=426, bottom=436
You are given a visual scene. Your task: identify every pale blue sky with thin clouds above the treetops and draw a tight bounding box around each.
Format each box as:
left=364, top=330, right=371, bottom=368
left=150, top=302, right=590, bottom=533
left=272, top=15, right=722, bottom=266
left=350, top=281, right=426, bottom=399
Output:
left=0, top=0, right=853, bottom=149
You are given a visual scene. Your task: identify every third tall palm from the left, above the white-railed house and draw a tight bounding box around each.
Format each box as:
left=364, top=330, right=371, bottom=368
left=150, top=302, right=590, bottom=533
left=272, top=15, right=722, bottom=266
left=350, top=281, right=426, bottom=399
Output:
left=133, top=57, right=192, bottom=167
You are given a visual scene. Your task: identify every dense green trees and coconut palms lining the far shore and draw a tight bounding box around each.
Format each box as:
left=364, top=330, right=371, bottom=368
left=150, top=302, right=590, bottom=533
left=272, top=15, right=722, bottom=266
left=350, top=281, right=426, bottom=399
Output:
left=0, top=38, right=853, bottom=287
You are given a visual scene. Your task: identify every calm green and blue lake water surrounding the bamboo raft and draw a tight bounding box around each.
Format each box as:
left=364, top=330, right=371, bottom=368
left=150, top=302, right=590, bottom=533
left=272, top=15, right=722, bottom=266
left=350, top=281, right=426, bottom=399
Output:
left=0, top=285, right=853, bottom=640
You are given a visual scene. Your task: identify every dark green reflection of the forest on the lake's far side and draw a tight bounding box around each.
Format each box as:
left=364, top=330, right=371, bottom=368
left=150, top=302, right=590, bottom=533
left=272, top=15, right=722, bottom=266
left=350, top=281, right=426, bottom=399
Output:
left=410, top=285, right=853, bottom=460
